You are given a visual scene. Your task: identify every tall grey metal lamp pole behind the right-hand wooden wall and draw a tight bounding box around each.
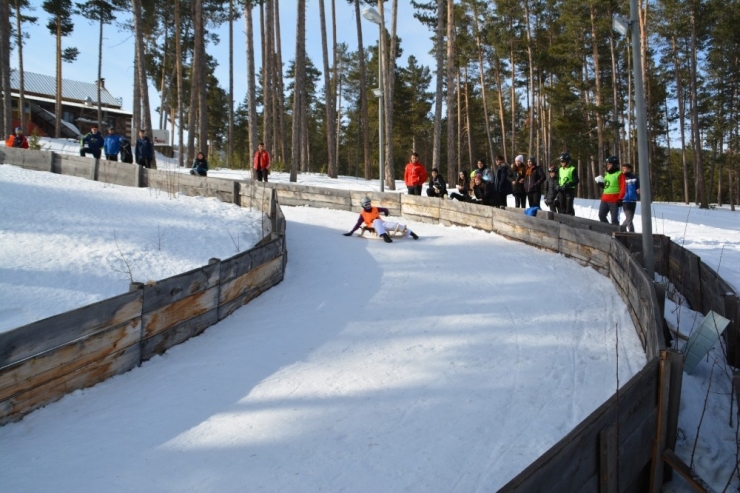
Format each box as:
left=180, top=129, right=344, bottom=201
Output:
left=630, top=0, right=655, bottom=281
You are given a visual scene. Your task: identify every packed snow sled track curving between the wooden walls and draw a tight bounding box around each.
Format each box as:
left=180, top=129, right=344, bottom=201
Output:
left=0, top=207, right=645, bottom=492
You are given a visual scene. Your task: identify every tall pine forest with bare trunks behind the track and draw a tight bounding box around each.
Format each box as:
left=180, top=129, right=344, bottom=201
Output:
left=0, top=0, right=740, bottom=207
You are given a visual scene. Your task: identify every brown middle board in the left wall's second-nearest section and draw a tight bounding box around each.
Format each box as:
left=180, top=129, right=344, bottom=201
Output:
left=143, top=282, right=219, bottom=339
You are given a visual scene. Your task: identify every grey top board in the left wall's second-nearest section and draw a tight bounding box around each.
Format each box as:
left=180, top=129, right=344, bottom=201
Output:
left=142, top=262, right=220, bottom=313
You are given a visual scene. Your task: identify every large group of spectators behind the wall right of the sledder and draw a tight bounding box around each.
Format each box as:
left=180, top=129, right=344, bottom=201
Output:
left=404, top=152, right=640, bottom=232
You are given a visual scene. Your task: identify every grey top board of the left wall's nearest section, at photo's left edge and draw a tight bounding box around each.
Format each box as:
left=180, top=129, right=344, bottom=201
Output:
left=0, top=291, right=142, bottom=369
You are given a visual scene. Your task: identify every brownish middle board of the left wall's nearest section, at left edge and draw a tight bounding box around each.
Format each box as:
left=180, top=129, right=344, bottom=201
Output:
left=0, top=318, right=141, bottom=400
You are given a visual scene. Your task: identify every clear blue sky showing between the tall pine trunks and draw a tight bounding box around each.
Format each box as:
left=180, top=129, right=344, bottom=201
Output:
left=11, top=0, right=434, bottom=121
